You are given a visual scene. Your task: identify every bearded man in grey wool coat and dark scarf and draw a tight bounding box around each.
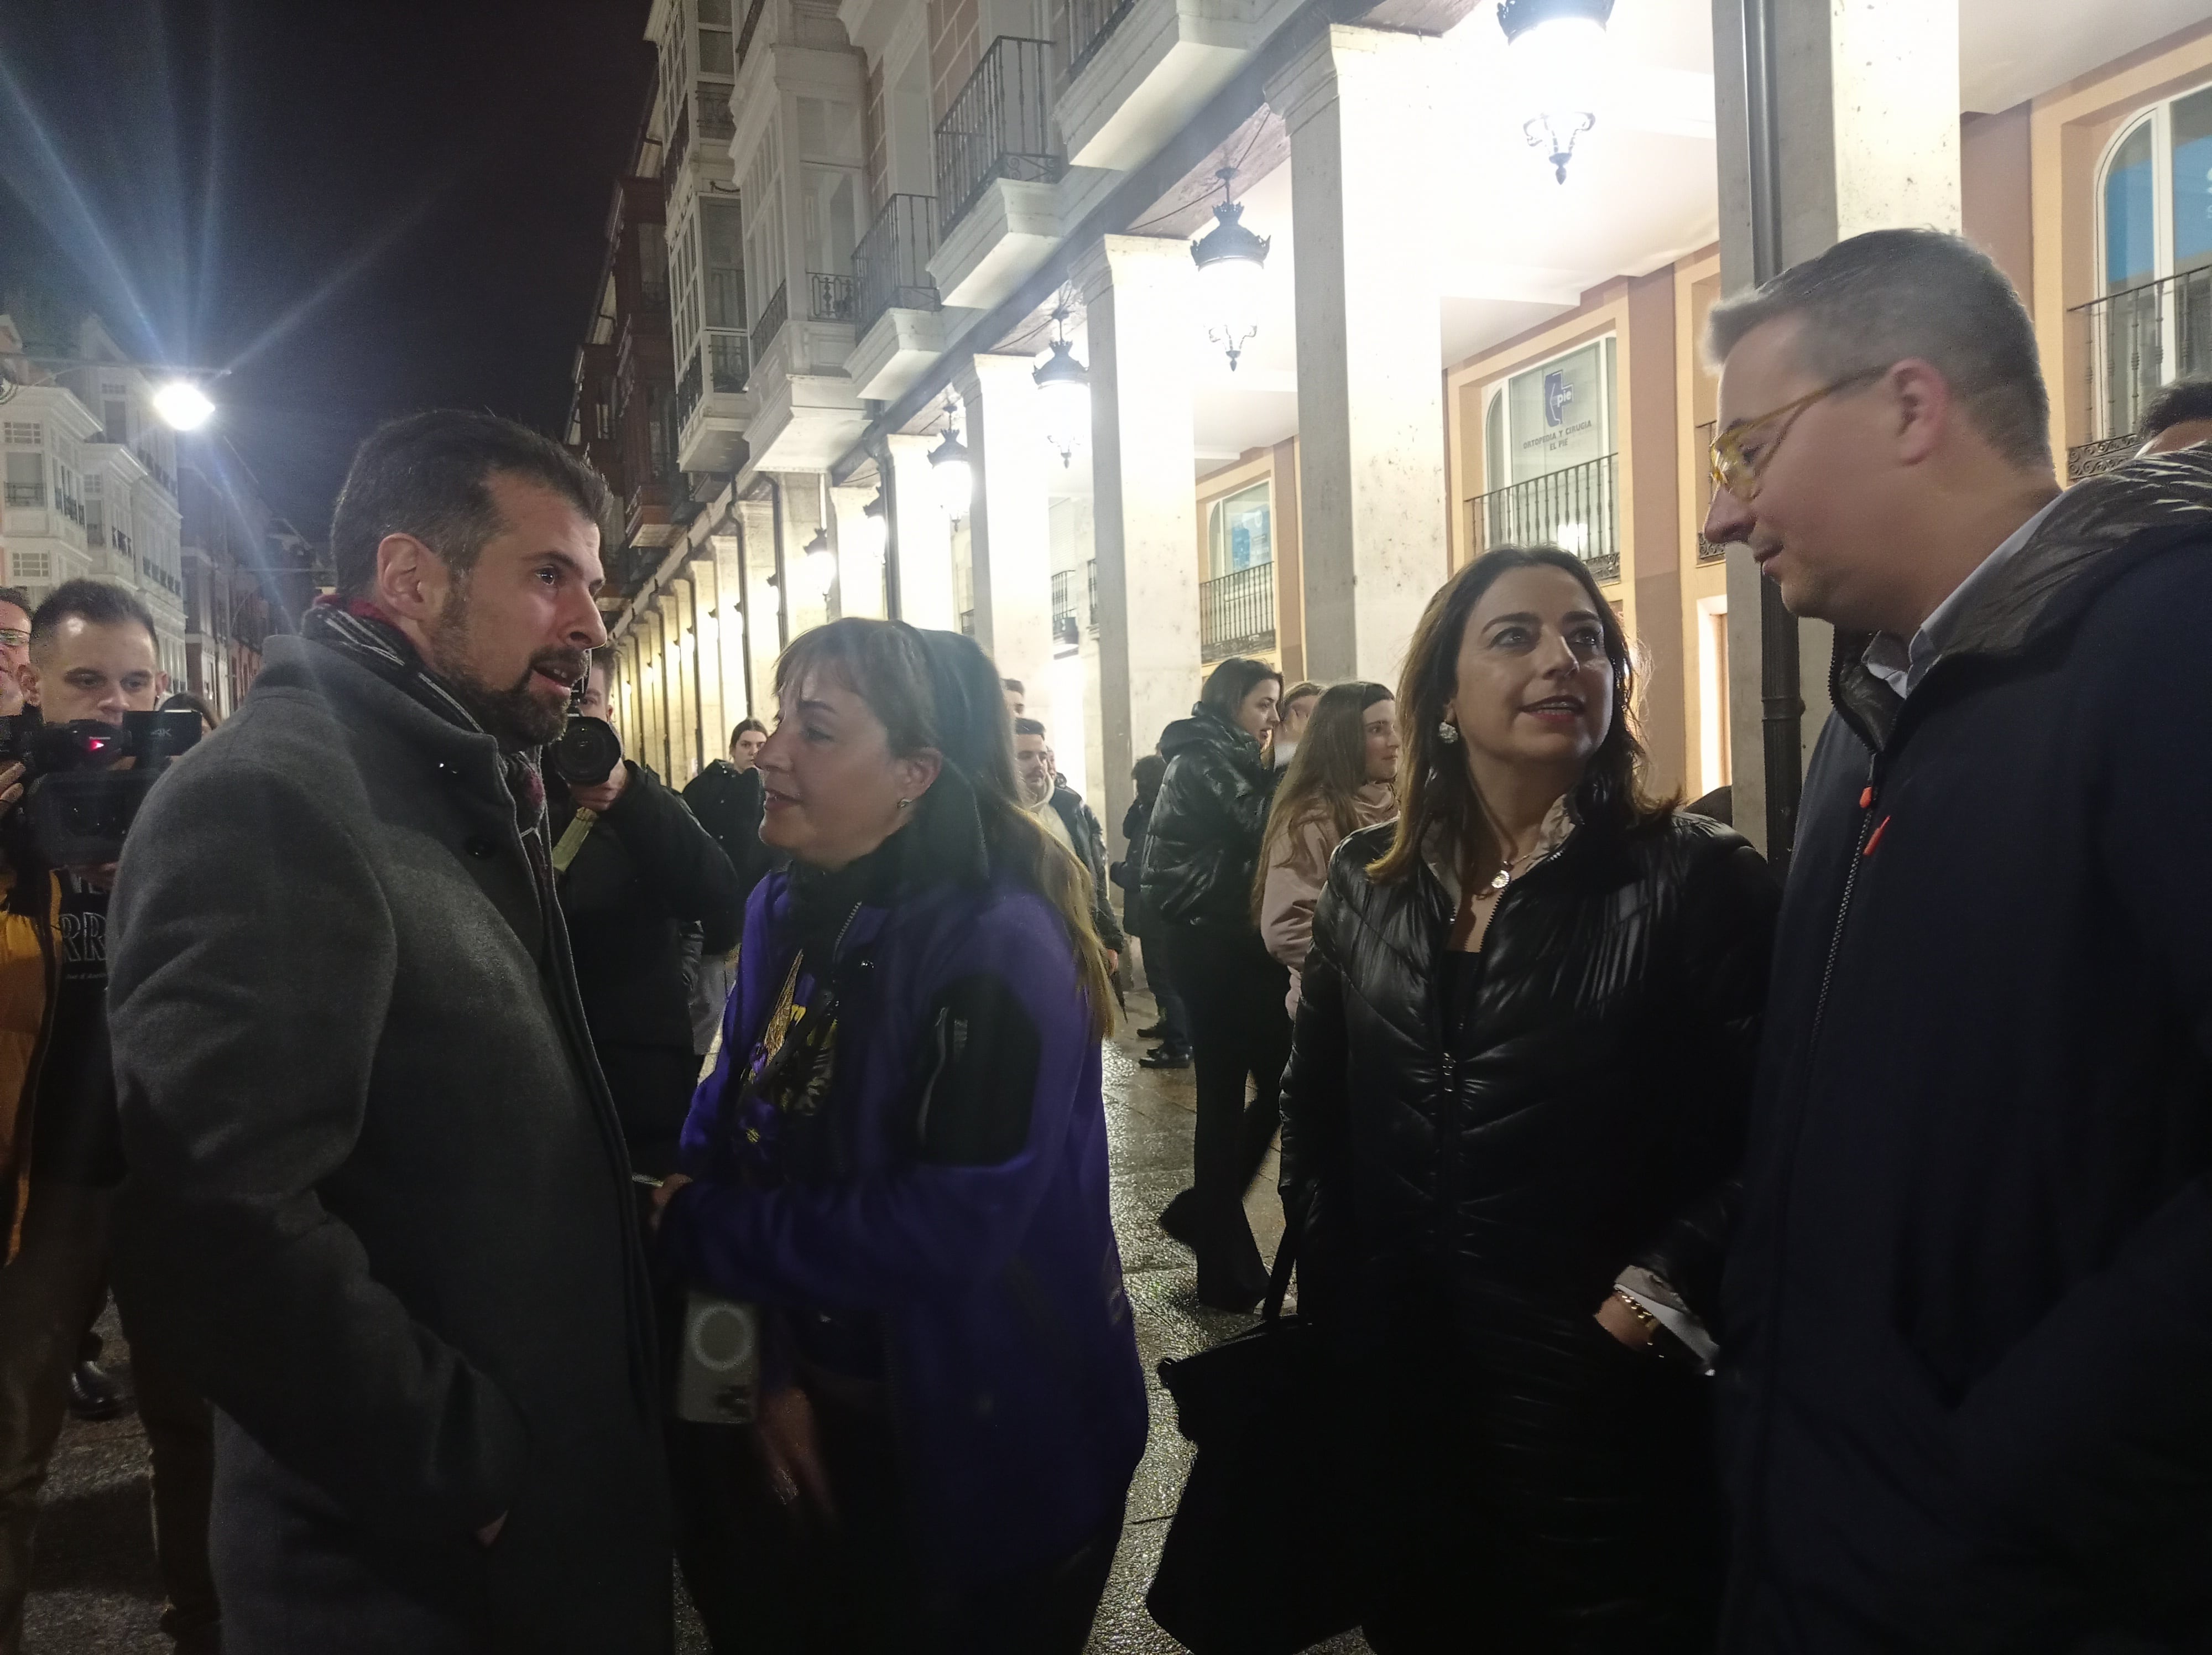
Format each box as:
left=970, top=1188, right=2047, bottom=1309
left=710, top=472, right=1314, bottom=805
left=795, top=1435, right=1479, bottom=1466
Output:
left=111, top=414, right=670, bottom=1655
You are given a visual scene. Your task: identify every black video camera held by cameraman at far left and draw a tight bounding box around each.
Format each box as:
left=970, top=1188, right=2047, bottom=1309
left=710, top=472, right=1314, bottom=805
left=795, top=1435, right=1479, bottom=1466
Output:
left=0, top=708, right=199, bottom=867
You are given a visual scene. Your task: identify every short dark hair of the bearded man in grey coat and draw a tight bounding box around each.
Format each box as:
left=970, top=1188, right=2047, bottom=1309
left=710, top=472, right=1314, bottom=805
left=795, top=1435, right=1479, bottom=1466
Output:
left=330, top=409, right=611, bottom=597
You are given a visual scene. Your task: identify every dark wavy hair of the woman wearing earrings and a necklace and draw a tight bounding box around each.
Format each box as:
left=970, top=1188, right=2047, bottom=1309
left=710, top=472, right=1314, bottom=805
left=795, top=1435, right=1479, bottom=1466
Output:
left=1367, top=547, right=1674, bottom=885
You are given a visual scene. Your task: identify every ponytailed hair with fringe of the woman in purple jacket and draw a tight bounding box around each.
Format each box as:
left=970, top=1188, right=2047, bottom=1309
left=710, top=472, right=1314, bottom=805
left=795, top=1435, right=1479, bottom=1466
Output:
left=776, top=617, right=1115, bottom=1040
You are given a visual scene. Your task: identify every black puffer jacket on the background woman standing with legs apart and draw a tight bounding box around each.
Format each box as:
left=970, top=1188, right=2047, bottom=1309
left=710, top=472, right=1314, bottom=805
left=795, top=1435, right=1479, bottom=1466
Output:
left=1144, top=701, right=1281, bottom=931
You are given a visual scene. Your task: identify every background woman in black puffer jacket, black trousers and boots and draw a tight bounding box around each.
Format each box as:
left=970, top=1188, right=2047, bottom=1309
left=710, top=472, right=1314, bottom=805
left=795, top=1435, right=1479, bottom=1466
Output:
left=1144, top=657, right=1290, bottom=1310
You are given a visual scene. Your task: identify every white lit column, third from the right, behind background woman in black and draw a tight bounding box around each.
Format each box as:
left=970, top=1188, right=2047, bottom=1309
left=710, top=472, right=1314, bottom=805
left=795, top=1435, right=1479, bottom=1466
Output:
left=1073, top=235, right=1201, bottom=852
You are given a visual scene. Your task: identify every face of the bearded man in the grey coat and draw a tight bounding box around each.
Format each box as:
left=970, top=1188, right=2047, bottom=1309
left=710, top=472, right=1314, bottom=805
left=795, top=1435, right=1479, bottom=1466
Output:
left=427, top=473, right=606, bottom=746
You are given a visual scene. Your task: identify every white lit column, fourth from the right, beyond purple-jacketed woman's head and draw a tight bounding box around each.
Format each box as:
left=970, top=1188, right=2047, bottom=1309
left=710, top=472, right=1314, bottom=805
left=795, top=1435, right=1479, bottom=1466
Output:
left=956, top=356, right=1053, bottom=728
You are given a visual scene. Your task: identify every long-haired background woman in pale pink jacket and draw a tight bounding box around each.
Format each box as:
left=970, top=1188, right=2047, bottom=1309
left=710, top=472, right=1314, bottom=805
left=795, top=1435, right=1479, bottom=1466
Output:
left=1252, top=684, right=1398, bottom=1016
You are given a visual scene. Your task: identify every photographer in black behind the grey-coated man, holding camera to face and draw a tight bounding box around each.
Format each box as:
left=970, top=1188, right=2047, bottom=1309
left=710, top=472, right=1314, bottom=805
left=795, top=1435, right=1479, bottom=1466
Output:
left=546, top=655, right=745, bottom=1175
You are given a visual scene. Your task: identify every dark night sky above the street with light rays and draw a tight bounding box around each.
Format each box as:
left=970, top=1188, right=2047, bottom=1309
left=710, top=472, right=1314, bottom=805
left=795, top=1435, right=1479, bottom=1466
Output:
left=0, top=0, right=653, bottom=540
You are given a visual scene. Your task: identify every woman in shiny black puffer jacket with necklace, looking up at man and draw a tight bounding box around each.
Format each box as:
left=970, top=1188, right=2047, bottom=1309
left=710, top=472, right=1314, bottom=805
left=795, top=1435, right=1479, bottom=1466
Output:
left=1283, top=549, right=1776, bottom=1655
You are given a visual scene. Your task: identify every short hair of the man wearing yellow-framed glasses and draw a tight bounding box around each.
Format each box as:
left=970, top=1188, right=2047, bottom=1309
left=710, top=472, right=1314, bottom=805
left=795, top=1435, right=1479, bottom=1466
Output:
left=1705, top=230, right=2051, bottom=467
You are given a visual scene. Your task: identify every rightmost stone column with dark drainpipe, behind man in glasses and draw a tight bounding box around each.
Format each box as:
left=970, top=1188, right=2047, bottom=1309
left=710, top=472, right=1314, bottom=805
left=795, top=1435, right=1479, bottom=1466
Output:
left=1712, top=0, right=1964, bottom=850
